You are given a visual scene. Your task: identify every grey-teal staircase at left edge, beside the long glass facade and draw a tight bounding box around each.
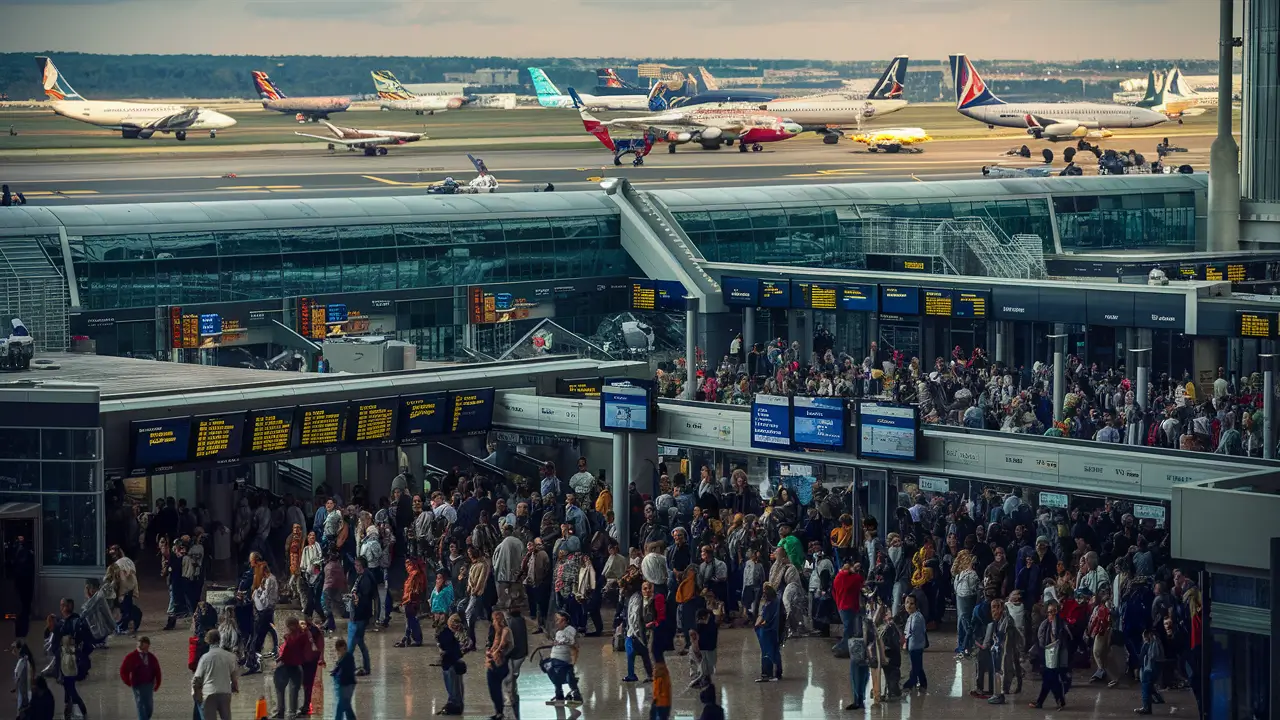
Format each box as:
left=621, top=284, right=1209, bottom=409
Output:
left=0, top=237, right=70, bottom=352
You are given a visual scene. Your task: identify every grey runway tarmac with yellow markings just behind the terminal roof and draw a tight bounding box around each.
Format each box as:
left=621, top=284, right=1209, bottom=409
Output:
left=3, top=135, right=1212, bottom=205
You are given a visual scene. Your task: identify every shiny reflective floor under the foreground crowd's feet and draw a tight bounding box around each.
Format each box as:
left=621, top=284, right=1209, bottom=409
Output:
left=15, top=592, right=1196, bottom=720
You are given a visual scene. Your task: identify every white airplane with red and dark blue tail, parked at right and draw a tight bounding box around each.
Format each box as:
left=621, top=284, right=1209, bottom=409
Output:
left=951, top=55, right=1169, bottom=140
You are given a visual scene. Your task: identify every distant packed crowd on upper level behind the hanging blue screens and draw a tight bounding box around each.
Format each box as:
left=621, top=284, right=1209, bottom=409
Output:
left=657, top=328, right=1263, bottom=457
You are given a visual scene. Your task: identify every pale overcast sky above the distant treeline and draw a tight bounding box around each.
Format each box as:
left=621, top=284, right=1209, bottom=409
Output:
left=0, top=0, right=1239, bottom=60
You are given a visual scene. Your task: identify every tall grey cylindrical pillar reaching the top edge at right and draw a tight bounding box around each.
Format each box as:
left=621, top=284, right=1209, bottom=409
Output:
left=1206, top=0, right=1240, bottom=252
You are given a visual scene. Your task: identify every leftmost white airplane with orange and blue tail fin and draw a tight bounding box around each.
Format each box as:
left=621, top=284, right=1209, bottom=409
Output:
left=36, top=56, right=236, bottom=140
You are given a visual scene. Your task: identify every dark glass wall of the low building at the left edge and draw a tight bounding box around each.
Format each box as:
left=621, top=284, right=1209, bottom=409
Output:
left=0, top=427, right=102, bottom=566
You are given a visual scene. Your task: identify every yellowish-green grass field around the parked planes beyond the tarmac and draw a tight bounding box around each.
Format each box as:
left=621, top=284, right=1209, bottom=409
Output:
left=0, top=104, right=1239, bottom=158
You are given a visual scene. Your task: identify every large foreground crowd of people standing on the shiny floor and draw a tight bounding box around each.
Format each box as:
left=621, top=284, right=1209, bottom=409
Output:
left=14, top=450, right=1202, bottom=720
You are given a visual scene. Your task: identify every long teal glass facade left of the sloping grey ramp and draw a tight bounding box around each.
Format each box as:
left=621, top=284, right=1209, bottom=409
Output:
left=50, top=215, right=634, bottom=310
